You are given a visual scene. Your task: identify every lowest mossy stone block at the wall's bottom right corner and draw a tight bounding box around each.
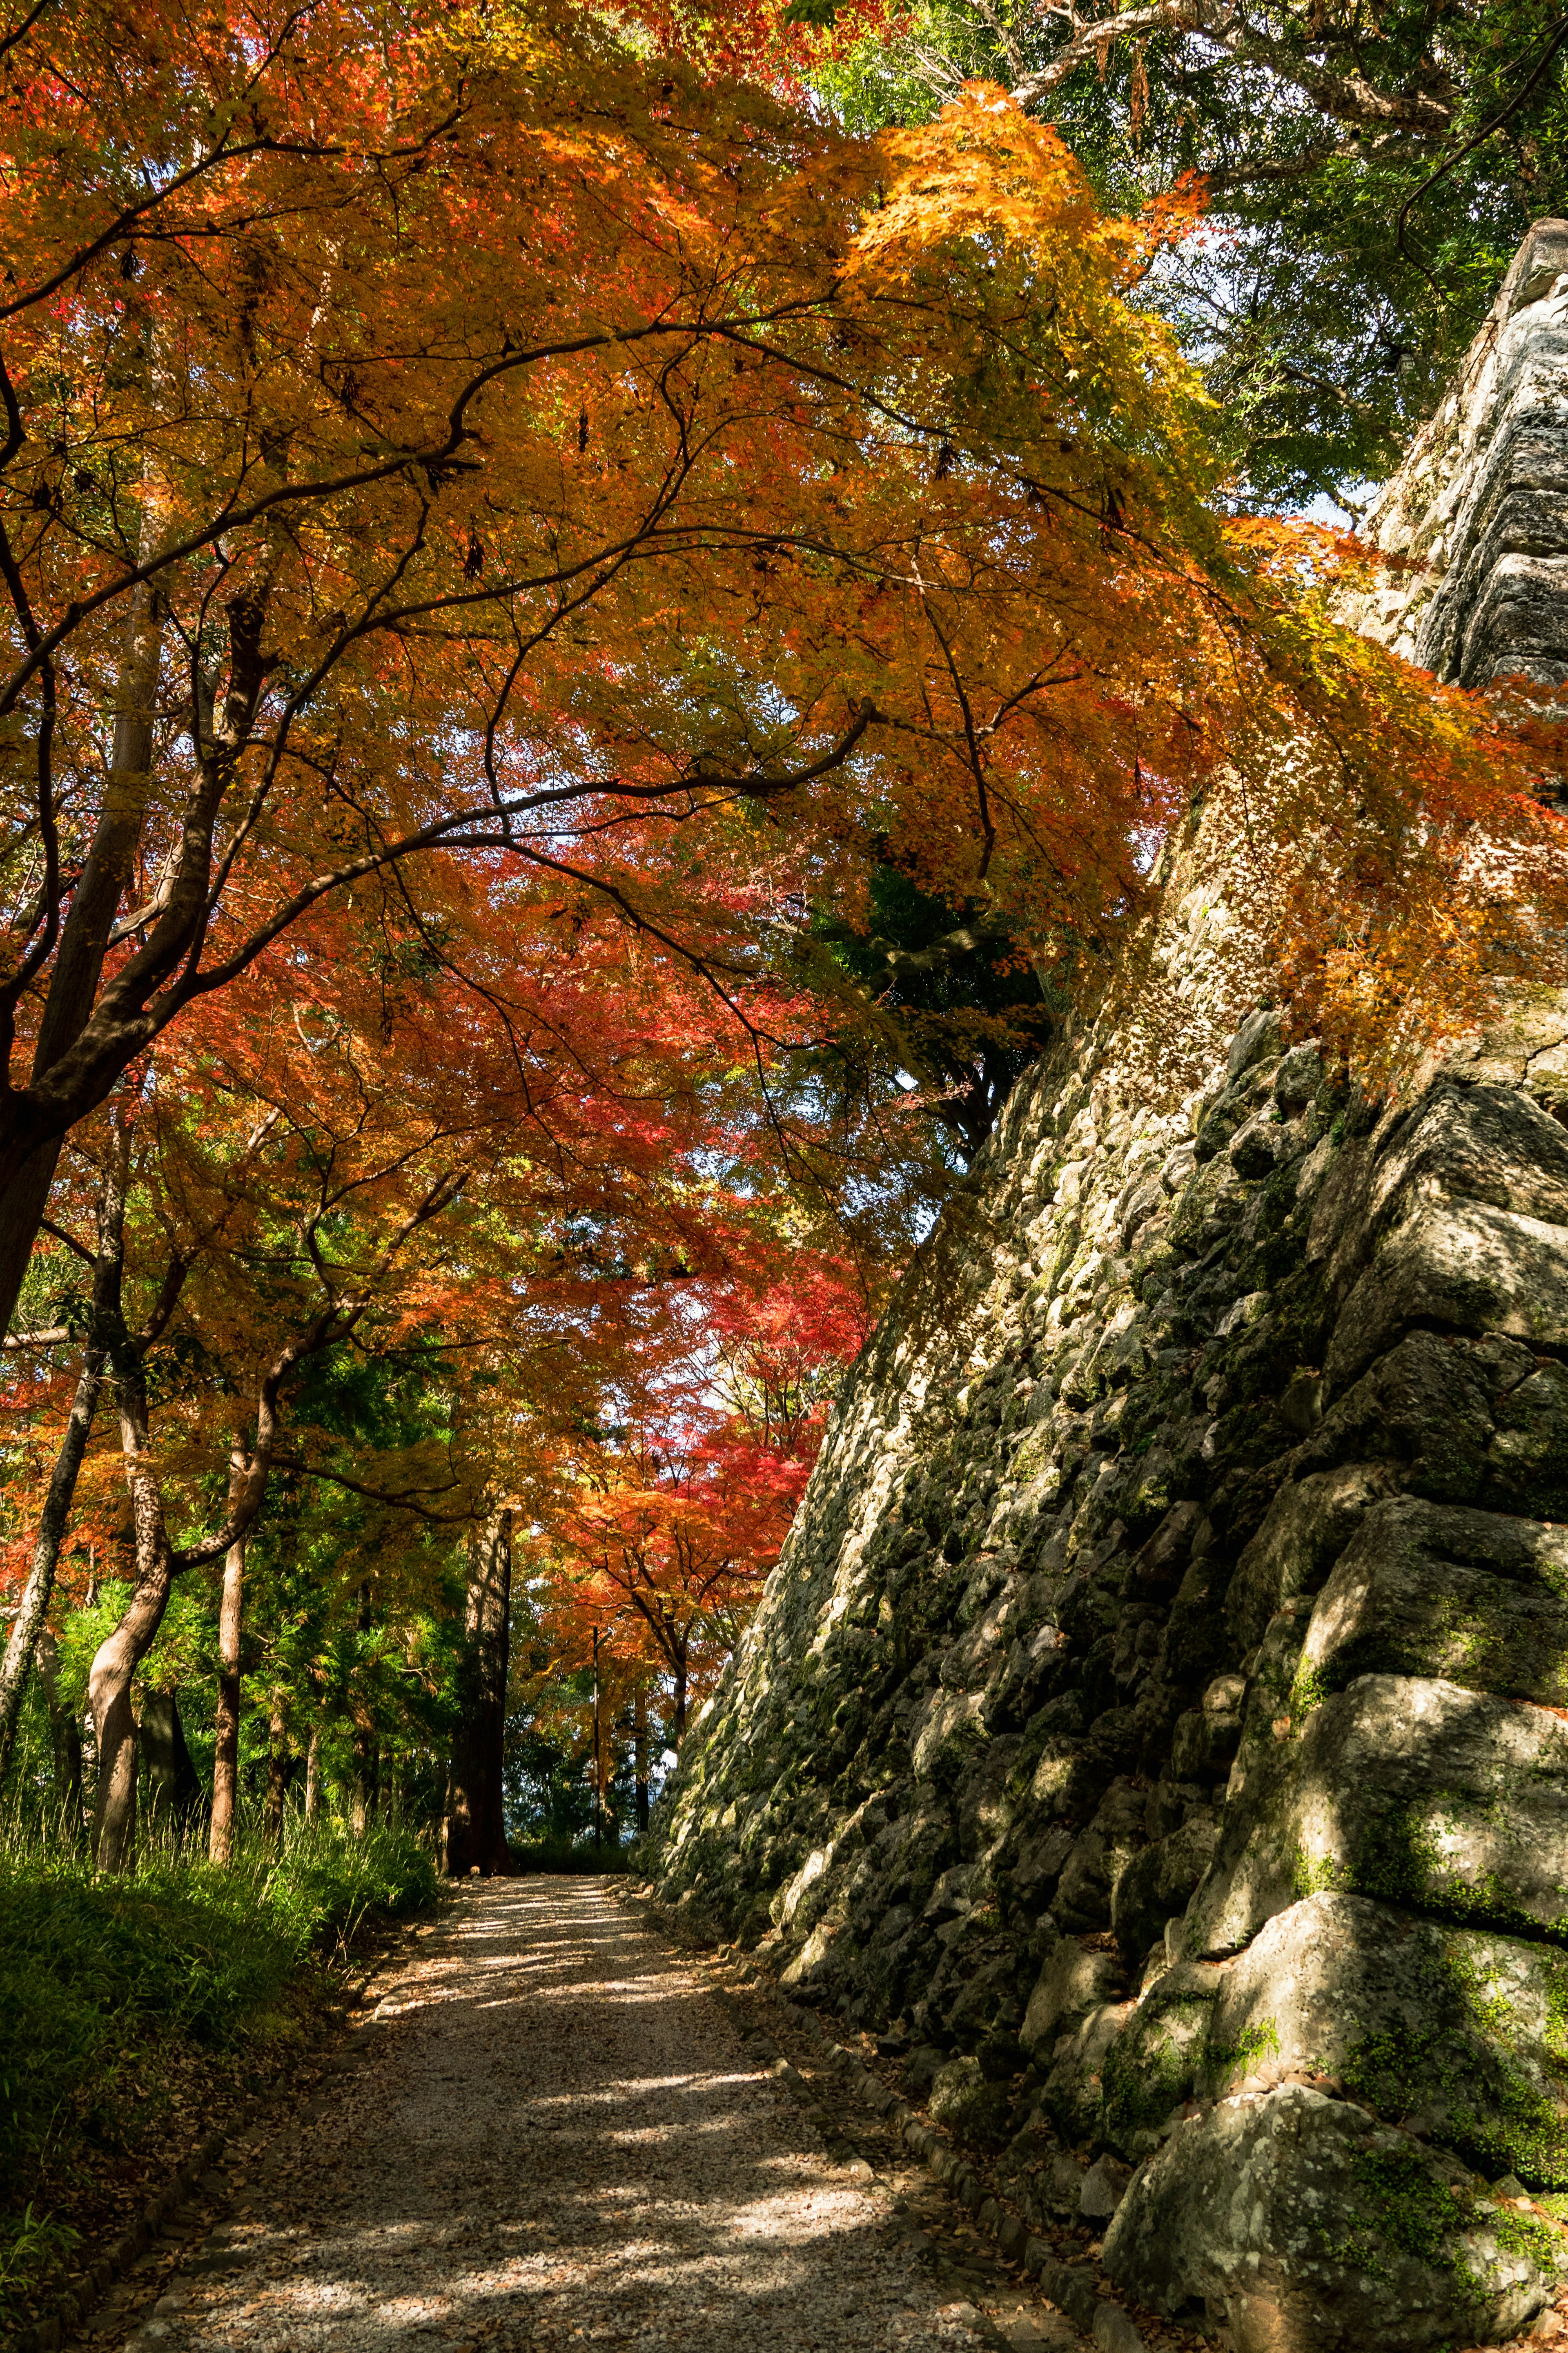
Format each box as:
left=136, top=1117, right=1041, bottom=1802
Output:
left=1105, top=2085, right=1556, bottom=2353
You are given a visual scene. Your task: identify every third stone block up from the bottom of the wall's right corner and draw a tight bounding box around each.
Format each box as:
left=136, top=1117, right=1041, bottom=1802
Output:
left=1185, top=1675, right=1568, bottom=1955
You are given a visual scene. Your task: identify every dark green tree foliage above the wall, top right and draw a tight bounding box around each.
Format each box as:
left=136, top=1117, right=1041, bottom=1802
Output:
left=818, top=0, right=1568, bottom=506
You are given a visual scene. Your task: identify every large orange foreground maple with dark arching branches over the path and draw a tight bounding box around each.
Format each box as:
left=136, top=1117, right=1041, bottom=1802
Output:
left=0, top=5, right=1523, bottom=1346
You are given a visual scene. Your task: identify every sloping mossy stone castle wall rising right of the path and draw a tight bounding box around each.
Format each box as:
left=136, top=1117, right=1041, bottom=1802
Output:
left=651, top=223, right=1568, bottom=2353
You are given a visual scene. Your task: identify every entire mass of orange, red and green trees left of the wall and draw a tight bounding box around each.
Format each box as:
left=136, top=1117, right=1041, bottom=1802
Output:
left=0, top=0, right=1556, bottom=1864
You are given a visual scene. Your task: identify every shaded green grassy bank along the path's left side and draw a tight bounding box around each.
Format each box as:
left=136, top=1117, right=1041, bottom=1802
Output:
left=0, top=1824, right=435, bottom=2339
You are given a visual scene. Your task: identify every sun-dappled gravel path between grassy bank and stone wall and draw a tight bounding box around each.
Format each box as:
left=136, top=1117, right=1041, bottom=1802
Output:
left=94, top=1878, right=1081, bottom=2353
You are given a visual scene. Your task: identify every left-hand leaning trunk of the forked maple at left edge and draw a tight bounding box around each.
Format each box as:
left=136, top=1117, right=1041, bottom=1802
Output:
left=0, top=560, right=162, bottom=1332
